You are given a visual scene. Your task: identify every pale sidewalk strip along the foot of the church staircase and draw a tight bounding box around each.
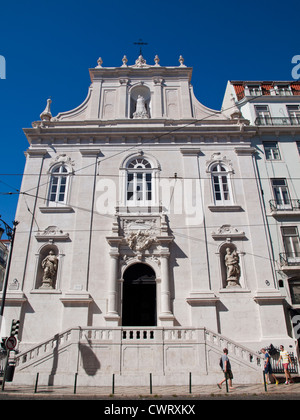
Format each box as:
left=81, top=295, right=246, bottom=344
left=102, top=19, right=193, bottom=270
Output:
left=0, top=383, right=300, bottom=400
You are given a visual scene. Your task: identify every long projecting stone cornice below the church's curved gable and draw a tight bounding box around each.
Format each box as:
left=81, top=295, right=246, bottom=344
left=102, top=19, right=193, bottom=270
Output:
left=24, top=120, right=256, bottom=149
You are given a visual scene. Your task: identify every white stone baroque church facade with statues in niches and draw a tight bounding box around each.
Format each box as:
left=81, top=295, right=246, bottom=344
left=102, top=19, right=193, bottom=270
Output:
left=2, top=56, right=295, bottom=385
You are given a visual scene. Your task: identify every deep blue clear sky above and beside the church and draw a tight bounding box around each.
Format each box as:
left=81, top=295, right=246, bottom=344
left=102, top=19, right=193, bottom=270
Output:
left=0, top=0, right=300, bottom=231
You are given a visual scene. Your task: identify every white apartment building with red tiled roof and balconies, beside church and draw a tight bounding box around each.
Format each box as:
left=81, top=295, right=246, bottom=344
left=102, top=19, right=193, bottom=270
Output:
left=223, top=81, right=300, bottom=350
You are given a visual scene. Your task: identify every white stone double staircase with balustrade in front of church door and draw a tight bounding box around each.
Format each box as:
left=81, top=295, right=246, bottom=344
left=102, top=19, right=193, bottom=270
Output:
left=14, top=327, right=263, bottom=386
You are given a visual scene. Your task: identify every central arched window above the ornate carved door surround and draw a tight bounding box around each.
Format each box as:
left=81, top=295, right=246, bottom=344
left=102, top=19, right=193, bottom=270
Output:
left=126, top=157, right=153, bottom=205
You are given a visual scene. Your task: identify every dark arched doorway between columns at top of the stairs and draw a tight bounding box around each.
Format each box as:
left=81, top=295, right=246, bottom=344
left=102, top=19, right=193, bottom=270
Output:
left=122, top=263, right=157, bottom=327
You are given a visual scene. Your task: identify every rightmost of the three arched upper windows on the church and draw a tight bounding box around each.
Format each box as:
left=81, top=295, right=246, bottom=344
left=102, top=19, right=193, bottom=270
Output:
left=211, top=162, right=232, bottom=205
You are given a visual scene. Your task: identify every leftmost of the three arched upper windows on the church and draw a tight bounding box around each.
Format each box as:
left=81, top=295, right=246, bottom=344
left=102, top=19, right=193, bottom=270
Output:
left=48, top=165, right=70, bottom=206
